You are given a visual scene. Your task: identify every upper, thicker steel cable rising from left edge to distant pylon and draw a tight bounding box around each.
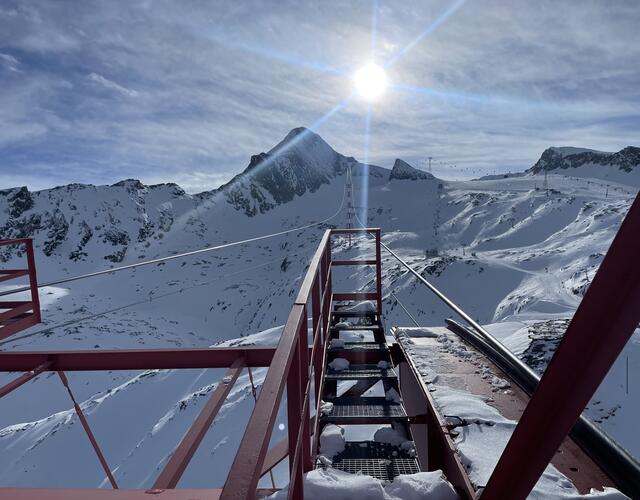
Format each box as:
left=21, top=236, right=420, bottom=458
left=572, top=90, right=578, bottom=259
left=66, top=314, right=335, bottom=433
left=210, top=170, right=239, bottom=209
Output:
left=0, top=186, right=345, bottom=297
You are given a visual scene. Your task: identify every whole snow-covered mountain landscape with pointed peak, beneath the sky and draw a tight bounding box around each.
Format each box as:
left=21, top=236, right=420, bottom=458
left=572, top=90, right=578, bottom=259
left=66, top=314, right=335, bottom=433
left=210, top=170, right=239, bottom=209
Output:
left=0, top=129, right=640, bottom=487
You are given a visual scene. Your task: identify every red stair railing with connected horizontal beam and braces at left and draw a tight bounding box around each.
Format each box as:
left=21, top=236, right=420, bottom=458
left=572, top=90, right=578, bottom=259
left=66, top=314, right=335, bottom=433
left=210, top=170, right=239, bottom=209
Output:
left=0, top=229, right=382, bottom=500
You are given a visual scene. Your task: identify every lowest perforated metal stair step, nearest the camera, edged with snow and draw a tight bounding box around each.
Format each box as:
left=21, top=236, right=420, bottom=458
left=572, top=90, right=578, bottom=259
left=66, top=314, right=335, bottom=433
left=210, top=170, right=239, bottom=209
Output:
left=316, top=441, right=420, bottom=481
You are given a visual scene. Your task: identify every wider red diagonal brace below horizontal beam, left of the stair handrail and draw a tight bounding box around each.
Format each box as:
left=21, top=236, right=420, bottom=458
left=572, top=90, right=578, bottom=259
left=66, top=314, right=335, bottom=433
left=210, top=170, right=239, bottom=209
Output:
left=153, top=358, right=245, bottom=489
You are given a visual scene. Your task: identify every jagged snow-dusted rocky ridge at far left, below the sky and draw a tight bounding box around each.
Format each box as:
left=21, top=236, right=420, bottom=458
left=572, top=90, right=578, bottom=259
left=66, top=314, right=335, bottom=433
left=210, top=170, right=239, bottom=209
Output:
left=0, top=179, right=194, bottom=262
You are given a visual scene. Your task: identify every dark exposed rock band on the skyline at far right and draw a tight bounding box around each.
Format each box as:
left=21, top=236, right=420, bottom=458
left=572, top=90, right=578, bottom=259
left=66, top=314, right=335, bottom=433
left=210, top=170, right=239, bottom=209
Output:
left=528, top=146, right=640, bottom=174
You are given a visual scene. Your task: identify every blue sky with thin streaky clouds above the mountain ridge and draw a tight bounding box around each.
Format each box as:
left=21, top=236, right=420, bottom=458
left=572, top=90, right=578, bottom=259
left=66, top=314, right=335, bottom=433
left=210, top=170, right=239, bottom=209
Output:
left=0, top=0, right=640, bottom=192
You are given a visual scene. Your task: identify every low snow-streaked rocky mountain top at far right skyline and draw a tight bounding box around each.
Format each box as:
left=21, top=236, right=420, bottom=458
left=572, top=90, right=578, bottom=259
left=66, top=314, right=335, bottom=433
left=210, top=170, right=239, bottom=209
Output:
left=529, top=146, right=640, bottom=186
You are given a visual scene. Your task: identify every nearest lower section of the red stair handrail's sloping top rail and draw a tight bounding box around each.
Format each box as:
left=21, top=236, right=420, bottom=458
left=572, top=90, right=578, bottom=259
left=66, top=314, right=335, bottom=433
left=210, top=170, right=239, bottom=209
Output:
left=220, top=304, right=305, bottom=500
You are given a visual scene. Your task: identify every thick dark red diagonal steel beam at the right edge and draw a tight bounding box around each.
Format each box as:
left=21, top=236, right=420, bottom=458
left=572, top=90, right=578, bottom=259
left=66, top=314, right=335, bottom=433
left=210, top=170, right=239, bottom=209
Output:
left=482, top=193, right=640, bottom=500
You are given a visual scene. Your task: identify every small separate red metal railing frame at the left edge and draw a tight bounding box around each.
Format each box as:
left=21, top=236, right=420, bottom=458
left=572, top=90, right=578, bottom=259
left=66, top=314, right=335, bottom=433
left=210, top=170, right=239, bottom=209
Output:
left=0, top=238, right=41, bottom=340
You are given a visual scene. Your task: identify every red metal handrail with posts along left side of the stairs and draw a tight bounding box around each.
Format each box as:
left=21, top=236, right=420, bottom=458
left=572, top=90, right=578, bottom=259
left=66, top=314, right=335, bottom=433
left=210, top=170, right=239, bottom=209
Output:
left=220, top=228, right=382, bottom=500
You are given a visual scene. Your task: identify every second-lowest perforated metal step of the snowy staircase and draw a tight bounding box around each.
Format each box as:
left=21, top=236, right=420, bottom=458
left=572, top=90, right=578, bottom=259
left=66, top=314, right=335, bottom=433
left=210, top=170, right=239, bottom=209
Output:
left=322, top=397, right=407, bottom=425
